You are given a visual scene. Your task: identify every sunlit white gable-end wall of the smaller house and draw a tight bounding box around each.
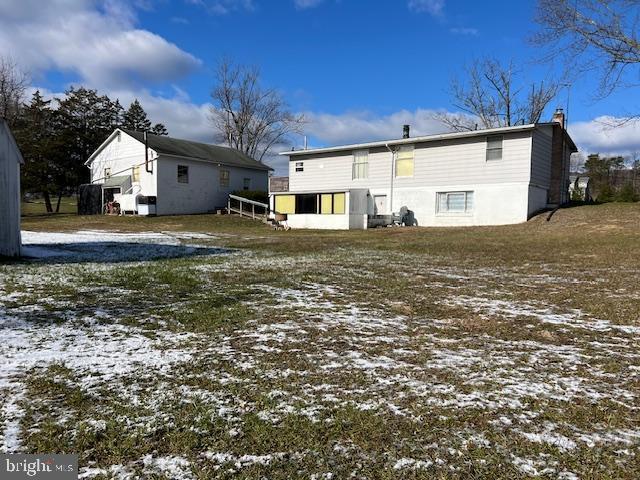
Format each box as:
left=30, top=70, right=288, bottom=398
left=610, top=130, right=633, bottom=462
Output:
left=90, top=129, right=158, bottom=196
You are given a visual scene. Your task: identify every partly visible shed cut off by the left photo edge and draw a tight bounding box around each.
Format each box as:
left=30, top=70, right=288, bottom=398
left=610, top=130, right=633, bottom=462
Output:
left=0, top=118, right=24, bottom=257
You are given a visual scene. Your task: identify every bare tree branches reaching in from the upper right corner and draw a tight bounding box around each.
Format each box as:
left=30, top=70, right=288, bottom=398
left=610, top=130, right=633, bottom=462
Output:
left=533, top=0, right=640, bottom=100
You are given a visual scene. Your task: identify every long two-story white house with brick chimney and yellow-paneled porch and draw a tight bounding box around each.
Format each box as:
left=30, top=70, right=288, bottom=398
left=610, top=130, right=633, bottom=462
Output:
left=270, top=110, right=577, bottom=229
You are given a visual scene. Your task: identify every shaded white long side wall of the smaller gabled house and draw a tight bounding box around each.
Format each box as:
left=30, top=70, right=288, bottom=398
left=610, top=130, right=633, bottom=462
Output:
left=157, top=155, right=269, bottom=215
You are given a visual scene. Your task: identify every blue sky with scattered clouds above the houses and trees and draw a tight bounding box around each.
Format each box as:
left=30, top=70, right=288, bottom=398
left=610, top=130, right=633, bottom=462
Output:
left=0, top=0, right=640, bottom=172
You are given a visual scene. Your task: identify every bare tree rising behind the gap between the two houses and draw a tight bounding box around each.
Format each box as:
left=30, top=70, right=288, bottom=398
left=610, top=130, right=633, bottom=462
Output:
left=211, top=60, right=304, bottom=161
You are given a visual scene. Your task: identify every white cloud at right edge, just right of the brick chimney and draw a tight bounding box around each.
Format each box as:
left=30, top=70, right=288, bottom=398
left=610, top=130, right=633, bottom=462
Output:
left=568, top=116, right=640, bottom=155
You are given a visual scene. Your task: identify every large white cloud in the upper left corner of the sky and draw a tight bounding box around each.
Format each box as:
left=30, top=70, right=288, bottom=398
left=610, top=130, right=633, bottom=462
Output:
left=0, top=0, right=201, bottom=88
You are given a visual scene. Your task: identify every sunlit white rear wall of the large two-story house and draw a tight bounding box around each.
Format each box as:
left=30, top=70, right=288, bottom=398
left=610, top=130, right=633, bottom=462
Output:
left=289, top=131, right=536, bottom=226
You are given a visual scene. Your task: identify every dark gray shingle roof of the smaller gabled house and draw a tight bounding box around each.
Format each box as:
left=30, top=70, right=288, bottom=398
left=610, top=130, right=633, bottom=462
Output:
left=122, top=129, right=273, bottom=170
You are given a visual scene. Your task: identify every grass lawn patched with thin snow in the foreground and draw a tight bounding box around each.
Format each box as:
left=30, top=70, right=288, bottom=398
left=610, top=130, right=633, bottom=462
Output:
left=0, top=204, right=640, bottom=479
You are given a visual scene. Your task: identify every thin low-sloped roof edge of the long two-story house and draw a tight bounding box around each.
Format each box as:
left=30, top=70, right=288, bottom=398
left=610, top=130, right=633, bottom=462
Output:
left=280, top=122, right=578, bottom=157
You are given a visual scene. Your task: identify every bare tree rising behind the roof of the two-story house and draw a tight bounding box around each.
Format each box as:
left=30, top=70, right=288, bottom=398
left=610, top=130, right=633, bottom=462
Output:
left=434, top=59, right=559, bottom=132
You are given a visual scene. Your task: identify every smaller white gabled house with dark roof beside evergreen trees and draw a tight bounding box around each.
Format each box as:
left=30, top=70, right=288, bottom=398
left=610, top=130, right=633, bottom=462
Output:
left=86, top=129, right=272, bottom=215
